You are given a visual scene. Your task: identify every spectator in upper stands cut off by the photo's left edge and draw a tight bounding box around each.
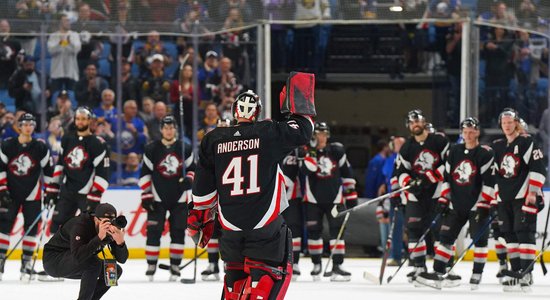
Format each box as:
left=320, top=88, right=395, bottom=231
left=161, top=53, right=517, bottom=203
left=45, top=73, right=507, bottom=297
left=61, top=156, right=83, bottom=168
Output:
left=0, top=19, right=21, bottom=90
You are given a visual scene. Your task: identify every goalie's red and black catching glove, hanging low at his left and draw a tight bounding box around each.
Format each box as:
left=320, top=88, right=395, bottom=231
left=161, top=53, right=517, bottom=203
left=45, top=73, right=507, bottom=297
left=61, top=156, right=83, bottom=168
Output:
left=187, top=208, right=216, bottom=248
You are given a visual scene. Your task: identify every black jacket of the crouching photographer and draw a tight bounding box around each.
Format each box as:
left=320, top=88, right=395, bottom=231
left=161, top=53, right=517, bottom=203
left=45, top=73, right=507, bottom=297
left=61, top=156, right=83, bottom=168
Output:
left=44, top=213, right=128, bottom=263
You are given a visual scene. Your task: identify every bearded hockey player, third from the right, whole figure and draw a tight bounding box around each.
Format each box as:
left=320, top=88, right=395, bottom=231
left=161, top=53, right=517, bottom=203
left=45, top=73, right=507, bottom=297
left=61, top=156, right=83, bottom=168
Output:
left=396, top=109, right=449, bottom=282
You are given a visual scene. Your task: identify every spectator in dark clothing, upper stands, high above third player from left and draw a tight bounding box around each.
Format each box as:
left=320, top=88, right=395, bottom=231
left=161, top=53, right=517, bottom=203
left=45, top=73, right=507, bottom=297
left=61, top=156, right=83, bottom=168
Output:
left=142, top=54, right=170, bottom=103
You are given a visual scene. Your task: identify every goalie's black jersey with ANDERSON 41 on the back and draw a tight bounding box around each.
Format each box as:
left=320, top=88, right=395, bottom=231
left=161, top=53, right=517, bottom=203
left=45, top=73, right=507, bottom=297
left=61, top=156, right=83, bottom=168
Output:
left=193, top=116, right=313, bottom=231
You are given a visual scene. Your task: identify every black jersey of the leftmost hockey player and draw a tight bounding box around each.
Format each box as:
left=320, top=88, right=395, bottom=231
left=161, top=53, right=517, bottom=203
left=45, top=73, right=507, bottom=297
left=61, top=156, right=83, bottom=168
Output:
left=0, top=138, right=53, bottom=201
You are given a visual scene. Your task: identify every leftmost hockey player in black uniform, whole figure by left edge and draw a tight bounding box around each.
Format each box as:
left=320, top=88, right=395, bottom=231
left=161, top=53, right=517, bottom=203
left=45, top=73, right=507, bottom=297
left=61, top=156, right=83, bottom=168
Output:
left=0, top=113, right=53, bottom=280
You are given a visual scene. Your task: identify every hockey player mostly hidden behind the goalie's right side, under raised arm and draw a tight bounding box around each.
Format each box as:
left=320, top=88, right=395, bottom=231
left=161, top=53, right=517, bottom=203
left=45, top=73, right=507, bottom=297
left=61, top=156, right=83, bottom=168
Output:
left=283, top=149, right=304, bottom=280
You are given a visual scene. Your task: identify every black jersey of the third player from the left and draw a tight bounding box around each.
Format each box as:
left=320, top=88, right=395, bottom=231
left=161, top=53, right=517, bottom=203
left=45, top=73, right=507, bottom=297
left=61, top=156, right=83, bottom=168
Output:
left=139, top=140, right=195, bottom=203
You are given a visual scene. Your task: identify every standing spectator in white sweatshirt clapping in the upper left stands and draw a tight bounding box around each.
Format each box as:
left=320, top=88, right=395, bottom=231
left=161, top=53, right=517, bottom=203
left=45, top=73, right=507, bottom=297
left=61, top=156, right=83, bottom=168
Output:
left=48, top=15, right=81, bottom=93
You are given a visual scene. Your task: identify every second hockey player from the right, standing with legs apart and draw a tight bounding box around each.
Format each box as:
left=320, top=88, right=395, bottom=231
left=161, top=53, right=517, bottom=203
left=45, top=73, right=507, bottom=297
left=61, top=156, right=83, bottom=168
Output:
left=416, top=118, right=494, bottom=289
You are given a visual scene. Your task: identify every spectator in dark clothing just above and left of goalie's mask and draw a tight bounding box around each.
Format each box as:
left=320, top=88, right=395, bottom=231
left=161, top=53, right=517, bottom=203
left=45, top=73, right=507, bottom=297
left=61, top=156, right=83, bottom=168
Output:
left=206, top=57, right=242, bottom=104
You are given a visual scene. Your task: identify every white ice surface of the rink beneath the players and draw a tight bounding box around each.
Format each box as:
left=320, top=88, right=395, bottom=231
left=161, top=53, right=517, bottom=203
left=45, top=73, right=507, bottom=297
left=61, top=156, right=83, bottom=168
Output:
left=0, top=258, right=550, bottom=300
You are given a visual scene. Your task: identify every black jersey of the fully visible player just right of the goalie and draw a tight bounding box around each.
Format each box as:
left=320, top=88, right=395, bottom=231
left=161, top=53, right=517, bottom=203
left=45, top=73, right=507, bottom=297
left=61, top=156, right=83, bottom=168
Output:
left=301, top=143, right=355, bottom=204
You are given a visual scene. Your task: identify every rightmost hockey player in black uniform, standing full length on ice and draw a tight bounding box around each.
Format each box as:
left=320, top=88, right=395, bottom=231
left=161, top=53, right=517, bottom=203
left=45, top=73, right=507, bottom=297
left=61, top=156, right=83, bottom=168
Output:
left=493, top=109, right=546, bottom=291
